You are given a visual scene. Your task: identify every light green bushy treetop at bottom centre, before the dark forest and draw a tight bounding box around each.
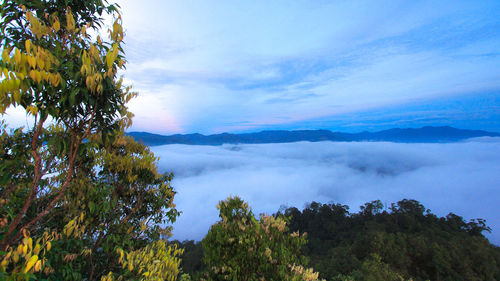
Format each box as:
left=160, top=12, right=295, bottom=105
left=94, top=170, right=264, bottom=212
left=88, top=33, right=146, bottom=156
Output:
left=202, top=197, right=318, bottom=281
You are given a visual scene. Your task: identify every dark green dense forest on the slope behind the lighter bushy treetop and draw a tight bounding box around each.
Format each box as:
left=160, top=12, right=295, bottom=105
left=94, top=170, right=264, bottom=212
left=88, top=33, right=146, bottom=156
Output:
left=175, top=199, right=500, bottom=281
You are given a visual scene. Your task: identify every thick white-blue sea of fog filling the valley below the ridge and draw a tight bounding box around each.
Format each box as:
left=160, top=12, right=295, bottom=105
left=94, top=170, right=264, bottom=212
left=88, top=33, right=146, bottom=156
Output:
left=152, top=138, right=500, bottom=245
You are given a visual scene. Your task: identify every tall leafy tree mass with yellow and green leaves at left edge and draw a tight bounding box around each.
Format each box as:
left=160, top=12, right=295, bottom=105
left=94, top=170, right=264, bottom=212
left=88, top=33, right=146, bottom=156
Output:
left=0, top=0, right=182, bottom=280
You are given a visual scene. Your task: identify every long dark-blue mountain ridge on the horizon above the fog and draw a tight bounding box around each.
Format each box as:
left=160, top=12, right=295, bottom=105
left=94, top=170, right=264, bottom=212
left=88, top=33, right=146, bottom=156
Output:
left=128, top=126, right=500, bottom=145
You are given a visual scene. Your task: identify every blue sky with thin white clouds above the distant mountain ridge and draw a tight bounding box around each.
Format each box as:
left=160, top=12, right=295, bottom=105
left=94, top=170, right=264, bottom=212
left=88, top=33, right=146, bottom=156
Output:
left=5, top=0, right=500, bottom=134
